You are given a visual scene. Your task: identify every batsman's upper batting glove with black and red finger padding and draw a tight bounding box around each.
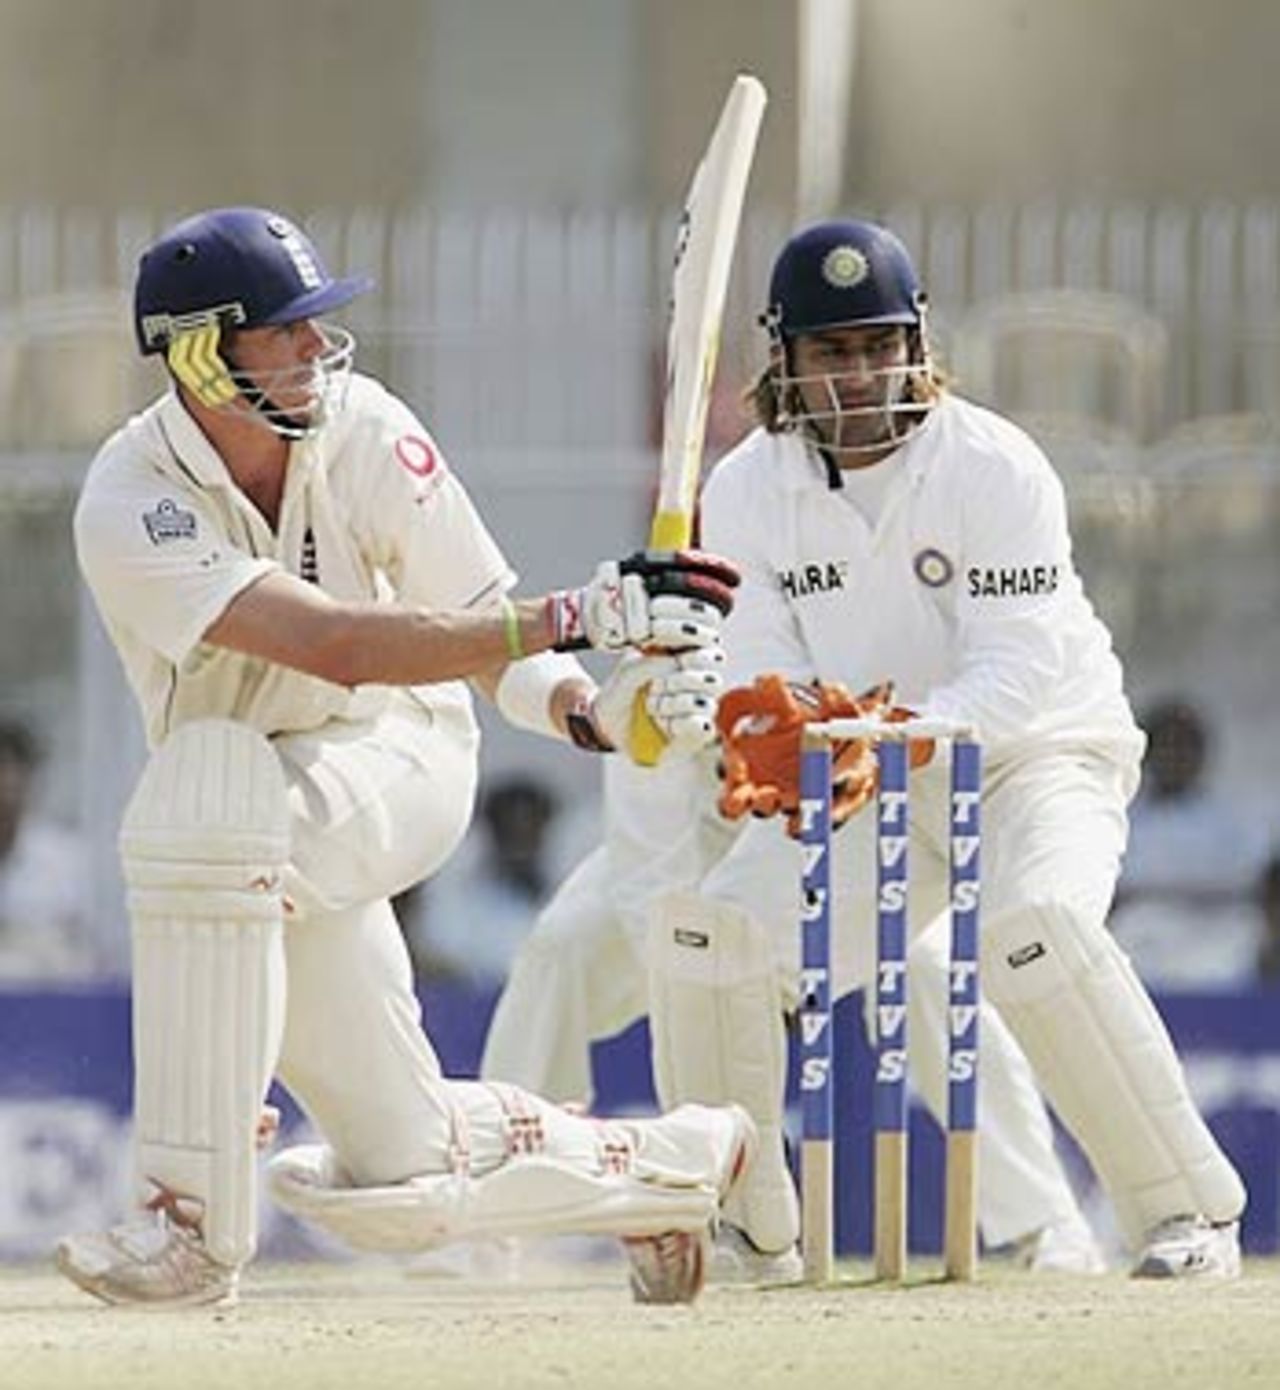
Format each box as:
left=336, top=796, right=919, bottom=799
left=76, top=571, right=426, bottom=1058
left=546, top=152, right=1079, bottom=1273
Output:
left=546, top=550, right=738, bottom=652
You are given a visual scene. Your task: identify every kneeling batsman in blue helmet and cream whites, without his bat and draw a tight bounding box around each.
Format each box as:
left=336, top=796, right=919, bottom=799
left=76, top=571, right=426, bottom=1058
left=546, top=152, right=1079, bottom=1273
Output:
left=57, top=209, right=753, bottom=1305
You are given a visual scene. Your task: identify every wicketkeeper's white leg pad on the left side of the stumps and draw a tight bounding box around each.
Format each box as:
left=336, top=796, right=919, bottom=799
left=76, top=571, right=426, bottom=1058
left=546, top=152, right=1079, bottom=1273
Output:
left=649, top=892, right=801, bottom=1252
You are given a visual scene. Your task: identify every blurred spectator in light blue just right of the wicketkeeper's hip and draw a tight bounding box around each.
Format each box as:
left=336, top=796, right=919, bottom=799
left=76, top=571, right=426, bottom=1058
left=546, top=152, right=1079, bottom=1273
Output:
left=1112, top=698, right=1266, bottom=990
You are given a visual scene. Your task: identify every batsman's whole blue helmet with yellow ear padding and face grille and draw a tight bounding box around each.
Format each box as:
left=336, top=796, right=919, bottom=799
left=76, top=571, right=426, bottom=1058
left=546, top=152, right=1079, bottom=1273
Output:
left=133, top=207, right=374, bottom=439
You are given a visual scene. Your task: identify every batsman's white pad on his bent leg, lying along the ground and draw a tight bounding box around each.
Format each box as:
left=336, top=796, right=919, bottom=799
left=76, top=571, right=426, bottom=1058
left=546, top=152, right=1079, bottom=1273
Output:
left=268, top=1088, right=748, bottom=1251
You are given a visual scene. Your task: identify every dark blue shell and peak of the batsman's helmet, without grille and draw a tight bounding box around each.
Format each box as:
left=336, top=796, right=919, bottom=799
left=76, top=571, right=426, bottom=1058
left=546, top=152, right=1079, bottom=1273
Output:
left=133, top=207, right=374, bottom=356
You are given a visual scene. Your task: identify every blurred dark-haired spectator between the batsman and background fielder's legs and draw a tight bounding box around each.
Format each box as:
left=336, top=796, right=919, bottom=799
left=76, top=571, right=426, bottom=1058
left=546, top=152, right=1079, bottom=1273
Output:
left=402, top=774, right=560, bottom=988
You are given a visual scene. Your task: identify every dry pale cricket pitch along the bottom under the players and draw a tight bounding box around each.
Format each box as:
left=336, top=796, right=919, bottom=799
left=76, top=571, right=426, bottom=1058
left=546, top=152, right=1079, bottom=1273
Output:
left=0, top=1261, right=1280, bottom=1390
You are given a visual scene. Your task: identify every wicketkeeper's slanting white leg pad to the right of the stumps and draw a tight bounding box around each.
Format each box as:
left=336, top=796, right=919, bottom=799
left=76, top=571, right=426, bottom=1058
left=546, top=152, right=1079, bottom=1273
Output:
left=984, top=904, right=1245, bottom=1241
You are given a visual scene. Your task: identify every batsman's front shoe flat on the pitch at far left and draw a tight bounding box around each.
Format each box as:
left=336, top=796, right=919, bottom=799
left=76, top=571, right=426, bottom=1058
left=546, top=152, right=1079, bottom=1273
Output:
left=54, top=1193, right=239, bottom=1308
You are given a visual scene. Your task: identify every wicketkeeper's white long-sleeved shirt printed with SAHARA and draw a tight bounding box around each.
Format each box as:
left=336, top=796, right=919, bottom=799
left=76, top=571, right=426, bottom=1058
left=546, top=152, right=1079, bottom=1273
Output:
left=702, top=395, right=1144, bottom=759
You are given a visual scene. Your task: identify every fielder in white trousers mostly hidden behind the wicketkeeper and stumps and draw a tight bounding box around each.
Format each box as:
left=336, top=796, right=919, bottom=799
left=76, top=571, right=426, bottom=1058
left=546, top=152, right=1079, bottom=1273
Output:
left=481, top=749, right=1105, bottom=1284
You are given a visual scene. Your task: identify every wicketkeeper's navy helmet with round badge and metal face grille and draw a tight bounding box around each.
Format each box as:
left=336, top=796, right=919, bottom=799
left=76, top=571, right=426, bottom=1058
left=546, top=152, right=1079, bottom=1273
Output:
left=756, top=221, right=937, bottom=452
